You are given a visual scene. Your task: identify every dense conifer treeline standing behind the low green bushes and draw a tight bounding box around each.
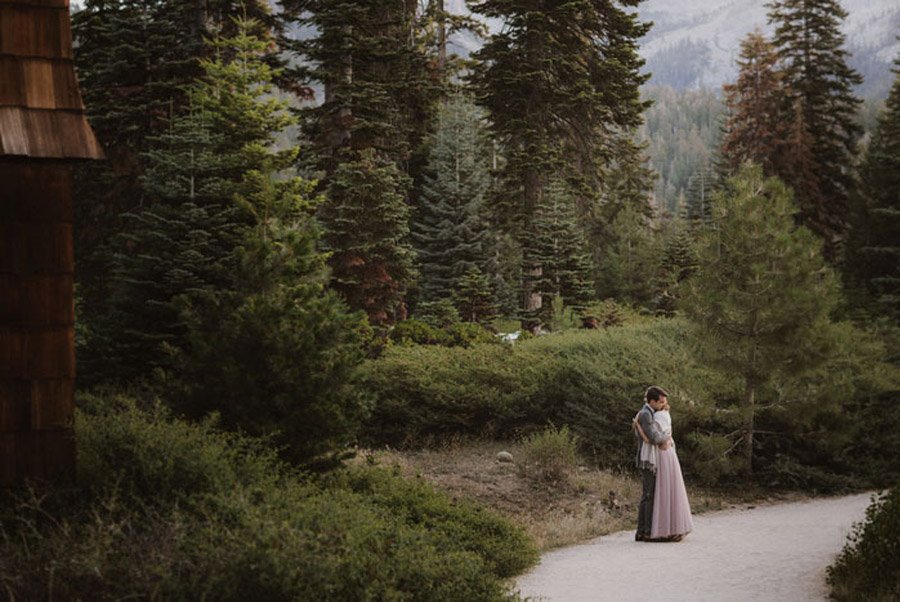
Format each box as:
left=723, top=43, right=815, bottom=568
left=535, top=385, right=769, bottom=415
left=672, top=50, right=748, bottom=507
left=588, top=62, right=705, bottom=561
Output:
left=65, top=0, right=897, bottom=470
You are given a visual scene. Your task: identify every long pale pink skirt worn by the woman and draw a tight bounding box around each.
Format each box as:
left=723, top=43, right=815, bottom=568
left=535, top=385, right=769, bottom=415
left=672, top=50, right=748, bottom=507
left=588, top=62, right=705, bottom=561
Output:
left=650, top=445, right=694, bottom=539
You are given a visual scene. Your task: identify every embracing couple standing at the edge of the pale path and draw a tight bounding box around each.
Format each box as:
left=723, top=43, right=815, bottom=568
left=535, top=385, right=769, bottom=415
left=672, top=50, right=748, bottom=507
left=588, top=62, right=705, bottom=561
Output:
left=633, top=386, right=694, bottom=541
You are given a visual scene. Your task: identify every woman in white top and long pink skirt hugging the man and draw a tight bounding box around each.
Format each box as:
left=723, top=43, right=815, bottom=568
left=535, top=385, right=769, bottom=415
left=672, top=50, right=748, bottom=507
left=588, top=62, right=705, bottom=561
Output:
left=634, top=402, right=694, bottom=541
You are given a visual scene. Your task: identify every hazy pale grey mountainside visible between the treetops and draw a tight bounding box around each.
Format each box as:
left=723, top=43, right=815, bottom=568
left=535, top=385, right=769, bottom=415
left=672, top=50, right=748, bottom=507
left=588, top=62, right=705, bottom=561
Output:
left=447, top=0, right=900, bottom=97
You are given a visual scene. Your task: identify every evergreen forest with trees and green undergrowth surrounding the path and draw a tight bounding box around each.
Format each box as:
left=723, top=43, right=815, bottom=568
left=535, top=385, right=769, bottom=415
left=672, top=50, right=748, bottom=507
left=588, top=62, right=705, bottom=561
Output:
left=0, top=0, right=900, bottom=600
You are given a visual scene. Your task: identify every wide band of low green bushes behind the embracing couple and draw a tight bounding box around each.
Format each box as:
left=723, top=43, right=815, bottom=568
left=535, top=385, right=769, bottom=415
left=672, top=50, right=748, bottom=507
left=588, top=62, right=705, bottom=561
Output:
left=360, top=318, right=900, bottom=492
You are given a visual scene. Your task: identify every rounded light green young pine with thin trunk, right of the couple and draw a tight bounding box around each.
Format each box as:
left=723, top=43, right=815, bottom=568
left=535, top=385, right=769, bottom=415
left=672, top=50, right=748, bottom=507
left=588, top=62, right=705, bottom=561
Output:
left=681, top=164, right=838, bottom=472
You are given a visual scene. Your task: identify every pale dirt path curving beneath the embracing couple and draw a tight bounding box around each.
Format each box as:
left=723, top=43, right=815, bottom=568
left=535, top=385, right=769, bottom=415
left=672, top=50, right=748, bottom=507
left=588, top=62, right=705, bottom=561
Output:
left=517, top=494, right=870, bottom=602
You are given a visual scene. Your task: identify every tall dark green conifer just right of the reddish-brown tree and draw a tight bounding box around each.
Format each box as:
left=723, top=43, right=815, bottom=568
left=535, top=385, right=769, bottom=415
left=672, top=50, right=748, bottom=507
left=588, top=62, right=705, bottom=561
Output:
left=766, top=0, right=862, bottom=262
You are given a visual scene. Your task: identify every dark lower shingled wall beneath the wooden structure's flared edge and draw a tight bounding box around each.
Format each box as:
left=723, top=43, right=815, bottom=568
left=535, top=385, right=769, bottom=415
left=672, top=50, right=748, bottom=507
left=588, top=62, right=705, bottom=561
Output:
left=0, top=160, right=75, bottom=486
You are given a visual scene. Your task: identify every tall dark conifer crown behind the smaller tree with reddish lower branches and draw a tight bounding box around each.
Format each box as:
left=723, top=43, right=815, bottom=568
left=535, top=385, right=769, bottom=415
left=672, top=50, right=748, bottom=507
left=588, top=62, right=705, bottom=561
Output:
left=281, top=0, right=438, bottom=175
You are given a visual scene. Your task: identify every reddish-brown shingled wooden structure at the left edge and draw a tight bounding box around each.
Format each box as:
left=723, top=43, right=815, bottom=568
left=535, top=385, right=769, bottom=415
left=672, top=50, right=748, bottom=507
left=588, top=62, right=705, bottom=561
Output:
left=0, top=0, right=102, bottom=487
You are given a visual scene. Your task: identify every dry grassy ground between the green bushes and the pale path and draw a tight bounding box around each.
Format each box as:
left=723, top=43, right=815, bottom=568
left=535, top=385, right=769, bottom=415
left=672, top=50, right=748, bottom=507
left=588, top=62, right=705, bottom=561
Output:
left=357, top=441, right=805, bottom=551
